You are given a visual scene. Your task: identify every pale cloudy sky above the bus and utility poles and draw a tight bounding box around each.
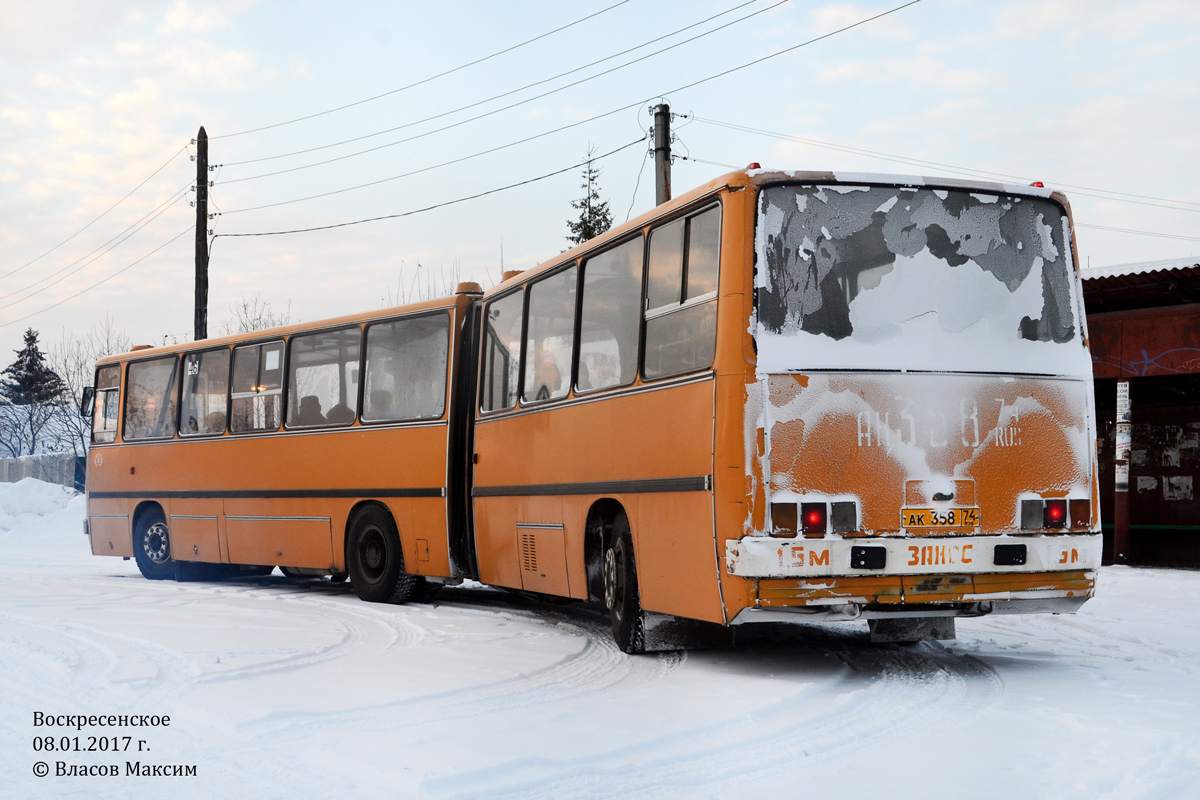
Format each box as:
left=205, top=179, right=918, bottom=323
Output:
left=0, top=0, right=1200, bottom=365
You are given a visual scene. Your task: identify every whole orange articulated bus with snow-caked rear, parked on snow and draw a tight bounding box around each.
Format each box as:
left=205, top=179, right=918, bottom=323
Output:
left=88, top=170, right=1100, bottom=652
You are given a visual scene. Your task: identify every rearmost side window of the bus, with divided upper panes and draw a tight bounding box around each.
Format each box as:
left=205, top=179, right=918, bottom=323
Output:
left=642, top=206, right=721, bottom=379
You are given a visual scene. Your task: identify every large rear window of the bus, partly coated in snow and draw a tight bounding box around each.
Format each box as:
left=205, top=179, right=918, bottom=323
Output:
left=755, top=185, right=1082, bottom=372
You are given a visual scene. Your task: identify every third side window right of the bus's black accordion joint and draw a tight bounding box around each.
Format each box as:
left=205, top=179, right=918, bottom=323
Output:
left=575, top=236, right=643, bottom=392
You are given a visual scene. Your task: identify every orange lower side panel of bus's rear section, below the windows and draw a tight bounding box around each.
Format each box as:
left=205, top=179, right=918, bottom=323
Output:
left=474, top=378, right=722, bottom=620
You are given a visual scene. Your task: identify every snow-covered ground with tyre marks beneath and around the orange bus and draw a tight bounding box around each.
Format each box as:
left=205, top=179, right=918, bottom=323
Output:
left=0, top=481, right=1200, bottom=799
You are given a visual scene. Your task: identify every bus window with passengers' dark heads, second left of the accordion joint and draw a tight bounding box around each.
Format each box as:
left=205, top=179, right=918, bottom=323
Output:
left=288, top=325, right=362, bottom=428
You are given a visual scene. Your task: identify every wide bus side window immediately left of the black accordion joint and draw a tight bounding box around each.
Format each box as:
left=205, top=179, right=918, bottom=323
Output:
left=362, top=314, right=450, bottom=422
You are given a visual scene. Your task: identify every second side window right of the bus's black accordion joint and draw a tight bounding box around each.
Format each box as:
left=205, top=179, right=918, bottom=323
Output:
left=521, top=265, right=578, bottom=403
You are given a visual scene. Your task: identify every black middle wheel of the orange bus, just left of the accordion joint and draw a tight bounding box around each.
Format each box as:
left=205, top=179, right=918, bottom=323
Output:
left=346, top=505, right=416, bottom=603
